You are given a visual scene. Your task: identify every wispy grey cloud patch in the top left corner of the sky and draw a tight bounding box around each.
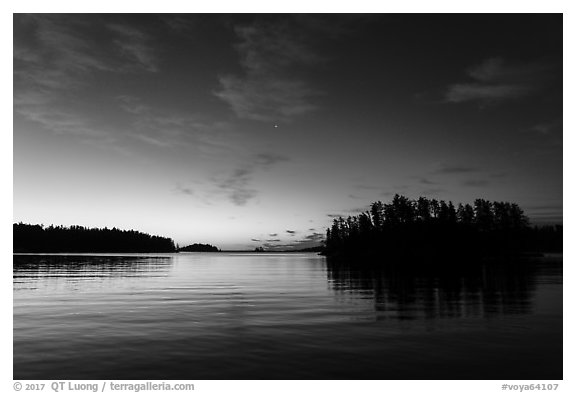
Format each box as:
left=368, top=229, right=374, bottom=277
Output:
left=13, top=14, right=157, bottom=89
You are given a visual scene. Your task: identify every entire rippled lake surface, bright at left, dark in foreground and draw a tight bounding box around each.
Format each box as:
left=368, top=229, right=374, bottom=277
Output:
left=14, top=253, right=562, bottom=380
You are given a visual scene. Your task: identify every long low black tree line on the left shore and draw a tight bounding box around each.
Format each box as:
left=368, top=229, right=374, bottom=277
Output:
left=13, top=222, right=176, bottom=252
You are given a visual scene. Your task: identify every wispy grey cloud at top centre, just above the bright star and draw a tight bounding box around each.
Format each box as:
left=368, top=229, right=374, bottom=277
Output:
left=214, top=19, right=319, bottom=121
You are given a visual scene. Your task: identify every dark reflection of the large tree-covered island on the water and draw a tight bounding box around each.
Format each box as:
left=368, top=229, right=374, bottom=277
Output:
left=327, top=260, right=550, bottom=319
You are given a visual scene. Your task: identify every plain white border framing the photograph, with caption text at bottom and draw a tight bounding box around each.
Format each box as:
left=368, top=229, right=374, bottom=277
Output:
left=0, top=0, right=576, bottom=393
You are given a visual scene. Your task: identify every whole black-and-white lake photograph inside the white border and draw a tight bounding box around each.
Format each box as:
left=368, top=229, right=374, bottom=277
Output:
left=11, top=7, right=568, bottom=392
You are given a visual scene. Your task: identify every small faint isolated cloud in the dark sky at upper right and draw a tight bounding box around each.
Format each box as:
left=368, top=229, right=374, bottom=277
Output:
left=445, top=57, right=556, bottom=105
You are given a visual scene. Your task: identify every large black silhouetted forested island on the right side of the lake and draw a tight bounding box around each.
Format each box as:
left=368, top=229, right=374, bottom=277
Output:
left=323, top=194, right=562, bottom=258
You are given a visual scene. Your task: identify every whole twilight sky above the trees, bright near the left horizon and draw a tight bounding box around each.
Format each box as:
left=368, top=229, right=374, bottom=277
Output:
left=13, top=14, right=563, bottom=249
